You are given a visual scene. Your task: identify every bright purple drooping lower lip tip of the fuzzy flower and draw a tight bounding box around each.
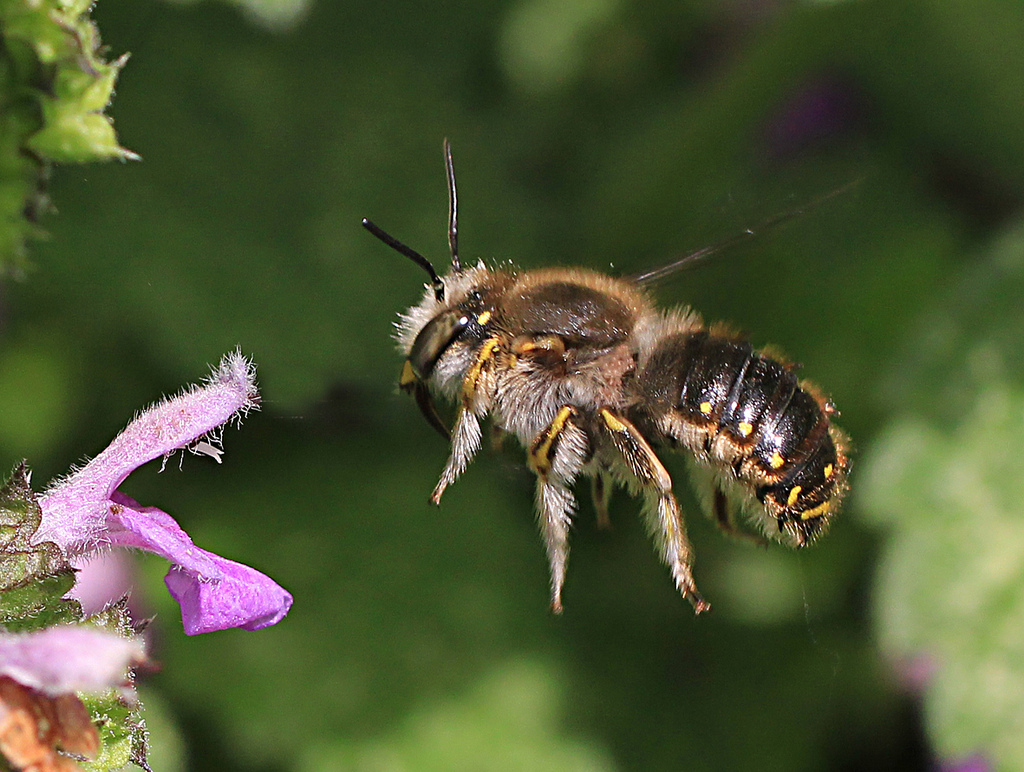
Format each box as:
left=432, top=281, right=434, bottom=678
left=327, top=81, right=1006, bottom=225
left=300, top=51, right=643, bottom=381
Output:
left=164, top=553, right=292, bottom=635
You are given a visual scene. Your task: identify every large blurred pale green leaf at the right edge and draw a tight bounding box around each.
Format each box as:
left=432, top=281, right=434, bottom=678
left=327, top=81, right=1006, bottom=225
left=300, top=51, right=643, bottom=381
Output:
left=861, top=228, right=1024, bottom=770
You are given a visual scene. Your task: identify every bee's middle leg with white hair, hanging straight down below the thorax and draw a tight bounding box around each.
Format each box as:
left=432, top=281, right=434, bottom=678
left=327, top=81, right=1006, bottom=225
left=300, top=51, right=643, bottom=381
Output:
left=527, top=405, right=590, bottom=613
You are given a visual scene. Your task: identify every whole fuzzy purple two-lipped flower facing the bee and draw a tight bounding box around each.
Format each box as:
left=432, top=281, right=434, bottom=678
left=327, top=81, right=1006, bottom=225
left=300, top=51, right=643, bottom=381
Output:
left=34, top=351, right=292, bottom=635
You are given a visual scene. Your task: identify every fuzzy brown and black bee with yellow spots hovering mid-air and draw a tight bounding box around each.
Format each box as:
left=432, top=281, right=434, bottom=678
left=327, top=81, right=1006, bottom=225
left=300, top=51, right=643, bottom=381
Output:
left=362, top=140, right=849, bottom=613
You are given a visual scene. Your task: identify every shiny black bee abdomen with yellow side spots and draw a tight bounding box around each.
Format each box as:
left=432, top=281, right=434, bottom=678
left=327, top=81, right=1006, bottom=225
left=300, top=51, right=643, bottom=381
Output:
left=637, top=330, right=846, bottom=521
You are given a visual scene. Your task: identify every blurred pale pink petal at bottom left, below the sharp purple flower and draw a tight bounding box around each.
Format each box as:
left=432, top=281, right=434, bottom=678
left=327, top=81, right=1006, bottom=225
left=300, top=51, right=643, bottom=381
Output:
left=0, top=627, right=144, bottom=696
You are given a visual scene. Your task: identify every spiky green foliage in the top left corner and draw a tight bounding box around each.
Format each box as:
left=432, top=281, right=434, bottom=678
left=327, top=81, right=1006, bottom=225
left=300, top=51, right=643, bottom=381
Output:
left=0, top=0, right=135, bottom=273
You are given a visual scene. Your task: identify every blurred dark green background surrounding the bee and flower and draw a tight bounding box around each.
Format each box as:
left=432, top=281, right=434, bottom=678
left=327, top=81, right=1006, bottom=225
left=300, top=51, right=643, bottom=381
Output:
left=0, top=0, right=1024, bottom=772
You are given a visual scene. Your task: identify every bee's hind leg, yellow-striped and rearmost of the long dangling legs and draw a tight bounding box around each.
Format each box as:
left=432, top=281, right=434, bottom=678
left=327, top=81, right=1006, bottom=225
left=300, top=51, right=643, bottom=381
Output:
left=600, top=409, right=711, bottom=613
